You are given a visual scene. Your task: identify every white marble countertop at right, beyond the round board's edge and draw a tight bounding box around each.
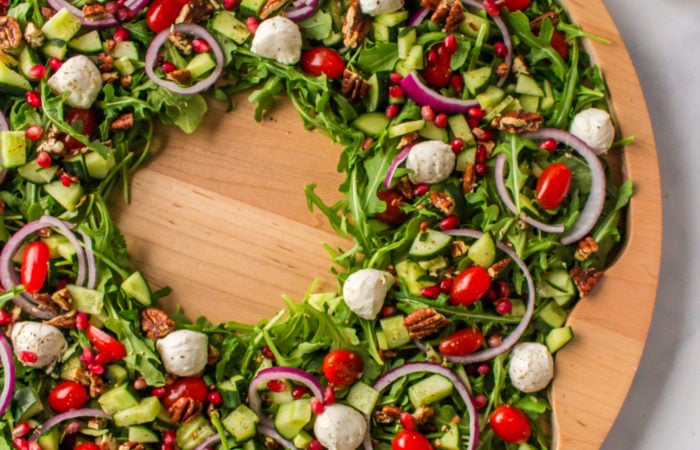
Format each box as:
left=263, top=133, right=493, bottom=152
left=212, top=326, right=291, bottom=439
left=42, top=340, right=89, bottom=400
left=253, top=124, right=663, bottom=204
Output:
left=603, top=0, right=700, bottom=450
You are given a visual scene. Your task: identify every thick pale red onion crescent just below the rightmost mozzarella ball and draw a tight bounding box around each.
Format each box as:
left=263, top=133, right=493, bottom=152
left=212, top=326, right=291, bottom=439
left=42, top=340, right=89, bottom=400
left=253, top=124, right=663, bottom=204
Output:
left=521, top=128, right=606, bottom=245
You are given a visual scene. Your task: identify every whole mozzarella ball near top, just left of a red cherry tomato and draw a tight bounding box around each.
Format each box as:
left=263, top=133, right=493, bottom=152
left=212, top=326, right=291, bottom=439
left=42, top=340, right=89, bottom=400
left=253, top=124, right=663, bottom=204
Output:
left=250, top=16, right=301, bottom=64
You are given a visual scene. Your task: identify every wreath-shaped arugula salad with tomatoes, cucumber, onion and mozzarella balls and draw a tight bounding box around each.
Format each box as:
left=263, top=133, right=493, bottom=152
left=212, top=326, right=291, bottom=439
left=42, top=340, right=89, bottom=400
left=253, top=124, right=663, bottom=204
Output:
left=0, top=0, right=632, bottom=450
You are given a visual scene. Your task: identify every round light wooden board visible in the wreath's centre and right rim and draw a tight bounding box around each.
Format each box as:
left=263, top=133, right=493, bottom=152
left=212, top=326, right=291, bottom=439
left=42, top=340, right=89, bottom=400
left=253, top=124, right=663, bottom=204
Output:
left=115, top=0, right=661, bottom=450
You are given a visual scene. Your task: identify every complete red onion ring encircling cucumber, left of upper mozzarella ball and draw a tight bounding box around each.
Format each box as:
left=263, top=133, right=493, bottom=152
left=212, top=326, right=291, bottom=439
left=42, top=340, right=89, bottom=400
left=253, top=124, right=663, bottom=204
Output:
left=144, top=23, right=224, bottom=95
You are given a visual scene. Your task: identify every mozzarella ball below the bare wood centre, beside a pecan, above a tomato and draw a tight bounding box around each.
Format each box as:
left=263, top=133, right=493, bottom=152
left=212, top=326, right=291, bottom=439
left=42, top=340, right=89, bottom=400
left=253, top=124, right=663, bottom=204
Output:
left=156, top=330, right=209, bottom=377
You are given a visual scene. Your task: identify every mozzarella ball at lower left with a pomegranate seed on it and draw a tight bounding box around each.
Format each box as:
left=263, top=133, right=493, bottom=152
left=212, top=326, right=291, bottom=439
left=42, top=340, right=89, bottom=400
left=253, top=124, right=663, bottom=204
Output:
left=10, top=322, right=68, bottom=369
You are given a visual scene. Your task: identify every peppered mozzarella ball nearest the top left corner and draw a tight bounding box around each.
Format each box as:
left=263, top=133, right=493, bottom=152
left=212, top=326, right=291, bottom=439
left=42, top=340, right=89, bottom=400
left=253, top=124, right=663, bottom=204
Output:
left=48, top=55, right=102, bottom=109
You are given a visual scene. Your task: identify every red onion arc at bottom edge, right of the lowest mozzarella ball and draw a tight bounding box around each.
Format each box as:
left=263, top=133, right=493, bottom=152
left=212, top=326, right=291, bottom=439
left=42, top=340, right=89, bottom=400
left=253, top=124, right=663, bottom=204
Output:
left=368, top=362, right=479, bottom=450
